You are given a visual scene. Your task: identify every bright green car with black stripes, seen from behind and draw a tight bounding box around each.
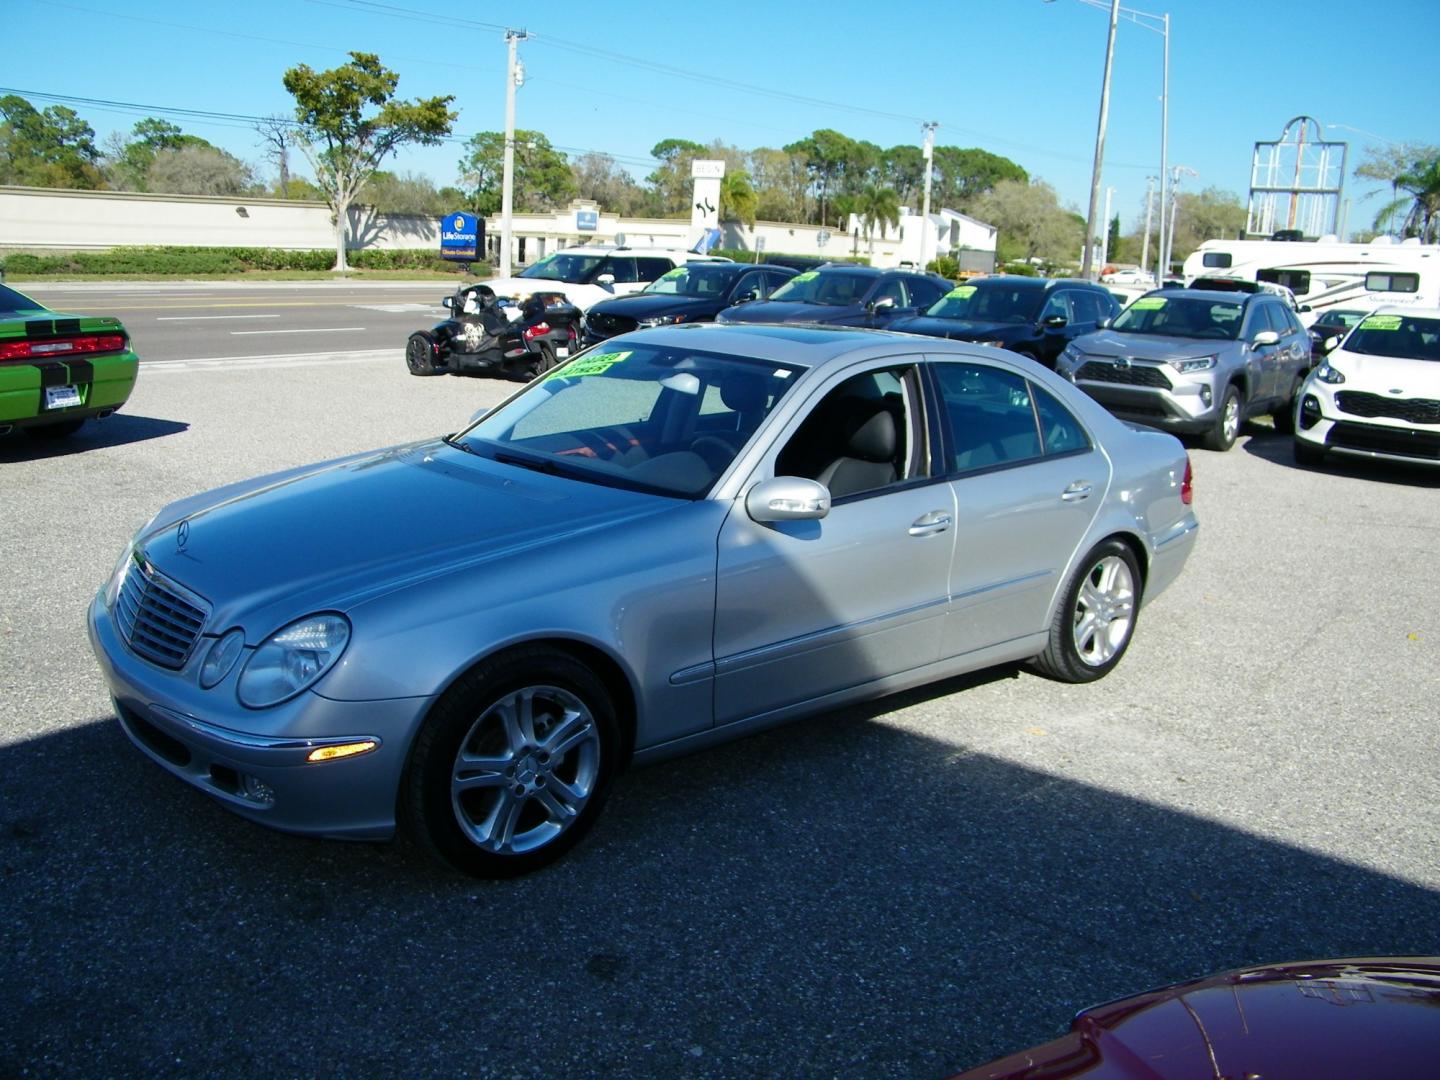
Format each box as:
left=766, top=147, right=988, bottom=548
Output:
left=0, top=285, right=140, bottom=439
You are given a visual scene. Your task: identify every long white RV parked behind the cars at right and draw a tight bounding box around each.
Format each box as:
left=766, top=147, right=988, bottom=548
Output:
left=1185, top=236, right=1440, bottom=312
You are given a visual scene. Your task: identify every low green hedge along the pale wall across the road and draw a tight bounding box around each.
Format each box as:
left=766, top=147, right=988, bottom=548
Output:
left=4, top=246, right=484, bottom=276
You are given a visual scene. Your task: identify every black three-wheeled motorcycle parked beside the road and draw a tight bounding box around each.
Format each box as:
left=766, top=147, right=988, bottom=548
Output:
left=405, top=285, right=580, bottom=379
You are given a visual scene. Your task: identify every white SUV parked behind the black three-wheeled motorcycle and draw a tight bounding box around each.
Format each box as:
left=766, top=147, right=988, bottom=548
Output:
left=480, top=245, right=729, bottom=311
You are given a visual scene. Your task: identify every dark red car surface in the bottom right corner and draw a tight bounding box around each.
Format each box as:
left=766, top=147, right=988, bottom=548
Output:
left=953, top=956, right=1440, bottom=1080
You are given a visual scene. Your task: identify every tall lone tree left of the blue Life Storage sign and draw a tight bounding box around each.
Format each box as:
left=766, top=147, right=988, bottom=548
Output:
left=284, top=52, right=456, bottom=271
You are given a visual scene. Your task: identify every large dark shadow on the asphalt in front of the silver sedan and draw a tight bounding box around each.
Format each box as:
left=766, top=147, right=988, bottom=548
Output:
left=0, top=696, right=1440, bottom=1077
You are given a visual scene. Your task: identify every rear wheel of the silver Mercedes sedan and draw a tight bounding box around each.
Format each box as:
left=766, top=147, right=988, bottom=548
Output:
left=1034, top=540, right=1140, bottom=683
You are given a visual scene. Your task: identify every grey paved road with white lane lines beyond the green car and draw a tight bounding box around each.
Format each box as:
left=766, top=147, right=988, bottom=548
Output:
left=19, top=281, right=454, bottom=363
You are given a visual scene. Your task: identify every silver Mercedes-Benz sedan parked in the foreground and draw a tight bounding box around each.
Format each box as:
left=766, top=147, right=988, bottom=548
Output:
left=89, top=325, right=1198, bottom=877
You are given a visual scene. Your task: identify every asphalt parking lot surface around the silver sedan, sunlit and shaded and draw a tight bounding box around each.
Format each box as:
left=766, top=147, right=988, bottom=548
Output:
left=0, top=336, right=1440, bottom=1077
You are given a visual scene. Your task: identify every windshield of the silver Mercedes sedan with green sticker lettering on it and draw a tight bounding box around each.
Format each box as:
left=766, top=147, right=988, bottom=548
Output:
left=456, top=344, right=796, bottom=498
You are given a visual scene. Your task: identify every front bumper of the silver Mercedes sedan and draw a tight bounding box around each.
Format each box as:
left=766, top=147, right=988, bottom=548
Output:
left=89, top=596, right=433, bottom=840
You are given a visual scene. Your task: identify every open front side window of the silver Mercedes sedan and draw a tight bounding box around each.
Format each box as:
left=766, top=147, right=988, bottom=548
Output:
left=775, top=367, right=929, bottom=498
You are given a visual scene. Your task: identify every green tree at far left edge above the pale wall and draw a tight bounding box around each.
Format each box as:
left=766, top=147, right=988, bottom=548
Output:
left=0, top=94, right=105, bottom=190
